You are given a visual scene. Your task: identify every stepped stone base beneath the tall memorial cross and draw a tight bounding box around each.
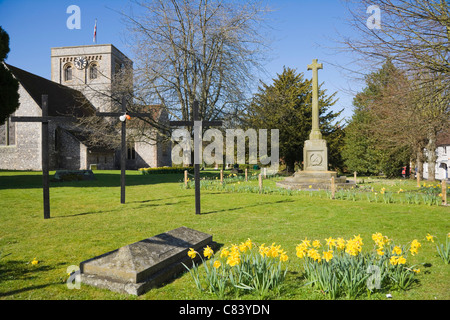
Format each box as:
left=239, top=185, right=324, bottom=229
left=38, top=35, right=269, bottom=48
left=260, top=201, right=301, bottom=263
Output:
left=276, top=171, right=355, bottom=190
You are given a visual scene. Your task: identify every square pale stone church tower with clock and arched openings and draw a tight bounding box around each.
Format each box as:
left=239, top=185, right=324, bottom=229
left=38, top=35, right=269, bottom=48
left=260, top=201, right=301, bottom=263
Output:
left=51, top=44, right=133, bottom=112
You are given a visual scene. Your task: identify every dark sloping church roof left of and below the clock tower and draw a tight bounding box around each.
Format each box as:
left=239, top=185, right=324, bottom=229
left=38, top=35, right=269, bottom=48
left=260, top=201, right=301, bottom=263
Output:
left=6, top=64, right=95, bottom=117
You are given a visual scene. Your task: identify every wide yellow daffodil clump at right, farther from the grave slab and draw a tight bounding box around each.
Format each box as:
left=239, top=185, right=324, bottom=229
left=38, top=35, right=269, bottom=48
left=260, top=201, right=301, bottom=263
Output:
left=296, top=233, right=421, bottom=299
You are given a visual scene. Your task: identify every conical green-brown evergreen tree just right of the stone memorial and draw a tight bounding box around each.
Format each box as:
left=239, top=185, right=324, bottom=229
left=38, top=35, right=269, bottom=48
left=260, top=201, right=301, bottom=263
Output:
left=343, top=59, right=410, bottom=177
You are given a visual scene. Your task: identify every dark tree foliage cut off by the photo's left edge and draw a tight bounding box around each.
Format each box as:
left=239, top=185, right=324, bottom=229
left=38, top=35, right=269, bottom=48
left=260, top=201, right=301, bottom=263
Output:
left=0, top=26, right=19, bottom=125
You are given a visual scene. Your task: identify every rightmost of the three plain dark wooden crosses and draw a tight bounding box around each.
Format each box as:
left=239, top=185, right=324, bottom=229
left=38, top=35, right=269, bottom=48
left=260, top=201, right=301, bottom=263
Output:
left=169, top=101, right=222, bottom=214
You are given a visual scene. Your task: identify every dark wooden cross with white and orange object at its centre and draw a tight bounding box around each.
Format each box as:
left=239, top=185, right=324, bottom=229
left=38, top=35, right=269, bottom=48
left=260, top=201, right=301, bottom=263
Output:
left=96, top=97, right=153, bottom=204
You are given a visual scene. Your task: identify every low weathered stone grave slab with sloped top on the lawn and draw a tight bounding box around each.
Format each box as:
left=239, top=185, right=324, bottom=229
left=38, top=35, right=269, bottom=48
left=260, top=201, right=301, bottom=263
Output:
left=80, top=227, right=216, bottom=295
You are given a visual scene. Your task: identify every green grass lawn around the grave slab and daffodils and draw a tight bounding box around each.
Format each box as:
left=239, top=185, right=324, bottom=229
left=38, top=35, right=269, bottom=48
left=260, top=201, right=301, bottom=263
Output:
left=0, top=171, right=450, bottom=300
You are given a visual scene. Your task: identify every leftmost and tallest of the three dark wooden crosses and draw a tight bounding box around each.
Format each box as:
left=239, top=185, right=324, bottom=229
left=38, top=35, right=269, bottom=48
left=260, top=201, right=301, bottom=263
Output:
left=11, top=94, right=76, bottom=219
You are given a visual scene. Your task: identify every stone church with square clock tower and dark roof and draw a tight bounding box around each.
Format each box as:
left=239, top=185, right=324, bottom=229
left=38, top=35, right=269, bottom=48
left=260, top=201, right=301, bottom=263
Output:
left=0, top=44, right=171, bottom=171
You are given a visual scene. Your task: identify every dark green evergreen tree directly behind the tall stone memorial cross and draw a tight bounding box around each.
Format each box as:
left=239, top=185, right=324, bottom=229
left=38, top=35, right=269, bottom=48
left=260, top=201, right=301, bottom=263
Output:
left=244, top=67, right=342, bottom=172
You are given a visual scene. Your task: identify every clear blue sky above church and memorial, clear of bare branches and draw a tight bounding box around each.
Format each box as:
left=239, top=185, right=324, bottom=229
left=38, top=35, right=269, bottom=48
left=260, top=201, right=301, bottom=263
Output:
left=0, top=0, right=369, bottom=119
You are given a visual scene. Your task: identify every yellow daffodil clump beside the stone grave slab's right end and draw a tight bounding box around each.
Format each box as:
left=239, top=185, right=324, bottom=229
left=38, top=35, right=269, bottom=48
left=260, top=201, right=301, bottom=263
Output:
left=185, top=239, right=289, bottom=299
